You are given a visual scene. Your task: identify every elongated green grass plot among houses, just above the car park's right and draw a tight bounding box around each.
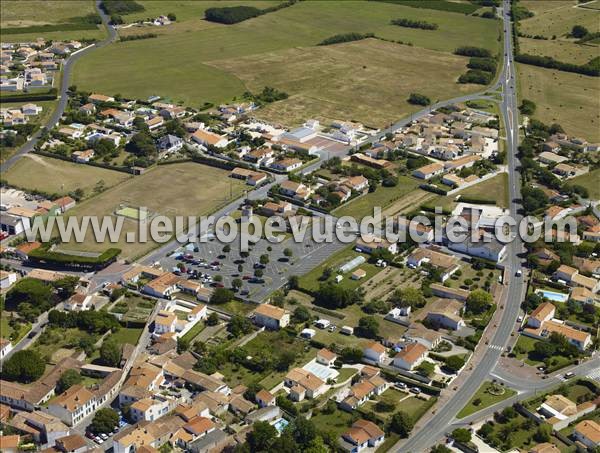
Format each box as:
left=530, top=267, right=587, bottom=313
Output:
left=334, top=176, right=420, bottom=219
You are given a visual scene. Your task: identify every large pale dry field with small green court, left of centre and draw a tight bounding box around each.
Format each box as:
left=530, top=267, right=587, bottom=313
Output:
left=60, top=162, right=245, bottom=259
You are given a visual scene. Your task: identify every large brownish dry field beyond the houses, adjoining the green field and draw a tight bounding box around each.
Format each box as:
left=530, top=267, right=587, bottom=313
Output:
left=212, top=39, right=481, bottom=127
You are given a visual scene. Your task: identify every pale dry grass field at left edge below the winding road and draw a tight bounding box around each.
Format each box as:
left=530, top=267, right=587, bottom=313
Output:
left=2, top=154, right=131, bottom=197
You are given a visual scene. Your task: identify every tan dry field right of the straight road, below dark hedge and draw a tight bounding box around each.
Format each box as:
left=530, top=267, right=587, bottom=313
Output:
left=517, top=64, right=600, bottom=142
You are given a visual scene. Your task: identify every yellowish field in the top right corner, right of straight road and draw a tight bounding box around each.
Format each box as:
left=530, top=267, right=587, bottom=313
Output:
left=520, top=0, right=600, bottom=39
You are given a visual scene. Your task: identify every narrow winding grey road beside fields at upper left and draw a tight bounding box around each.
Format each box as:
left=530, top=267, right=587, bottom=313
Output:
left=0, top=0, right=117, bottom=173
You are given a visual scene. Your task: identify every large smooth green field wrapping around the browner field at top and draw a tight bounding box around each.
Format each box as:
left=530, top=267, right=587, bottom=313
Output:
left=72, top=1, right=499, bottom=113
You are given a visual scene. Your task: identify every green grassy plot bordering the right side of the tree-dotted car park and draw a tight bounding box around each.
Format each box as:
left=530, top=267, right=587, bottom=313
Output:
left=299, top=245, right=382, bottom=291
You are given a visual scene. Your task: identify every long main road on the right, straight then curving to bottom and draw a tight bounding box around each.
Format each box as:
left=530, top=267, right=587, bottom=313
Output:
left=393, top=0, right=525, bottom=452
